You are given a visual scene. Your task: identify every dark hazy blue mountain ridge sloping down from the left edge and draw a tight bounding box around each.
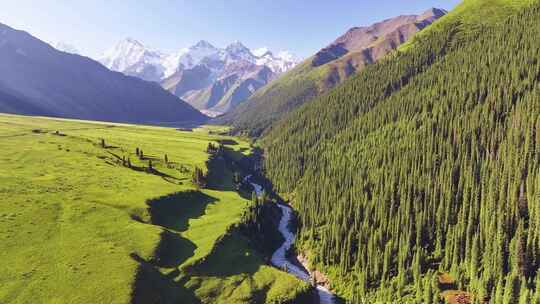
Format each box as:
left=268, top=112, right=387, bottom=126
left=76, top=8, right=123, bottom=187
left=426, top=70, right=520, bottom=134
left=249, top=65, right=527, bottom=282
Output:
left=0, top=24, right=207, bottom=125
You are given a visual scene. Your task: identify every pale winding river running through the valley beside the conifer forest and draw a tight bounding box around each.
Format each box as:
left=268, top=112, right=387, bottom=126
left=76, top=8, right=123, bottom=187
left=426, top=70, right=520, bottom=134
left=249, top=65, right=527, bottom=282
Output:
left=246, top=175, right=334, bottom=304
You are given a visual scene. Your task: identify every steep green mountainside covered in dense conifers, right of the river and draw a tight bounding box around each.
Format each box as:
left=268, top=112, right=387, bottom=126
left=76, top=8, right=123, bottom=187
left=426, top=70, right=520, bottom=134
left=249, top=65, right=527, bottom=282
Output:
left=261, top=0, right=540, bottom=304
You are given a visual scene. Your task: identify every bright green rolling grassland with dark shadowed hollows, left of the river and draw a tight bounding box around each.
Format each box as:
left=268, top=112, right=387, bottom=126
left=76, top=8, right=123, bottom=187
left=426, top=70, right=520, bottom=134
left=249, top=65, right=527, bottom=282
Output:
left=0, top=114, right=307, bottom=303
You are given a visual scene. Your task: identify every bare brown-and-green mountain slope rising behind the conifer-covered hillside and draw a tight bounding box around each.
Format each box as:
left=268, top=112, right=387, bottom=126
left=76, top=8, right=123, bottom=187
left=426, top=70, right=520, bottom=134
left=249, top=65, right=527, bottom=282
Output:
left=216, top=8, right=446, bottom=136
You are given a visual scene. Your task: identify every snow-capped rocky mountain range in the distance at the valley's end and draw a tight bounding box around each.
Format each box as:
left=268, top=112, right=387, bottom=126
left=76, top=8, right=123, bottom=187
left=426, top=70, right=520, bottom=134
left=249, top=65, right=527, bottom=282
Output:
left=98, top=38, right=298, bottom=115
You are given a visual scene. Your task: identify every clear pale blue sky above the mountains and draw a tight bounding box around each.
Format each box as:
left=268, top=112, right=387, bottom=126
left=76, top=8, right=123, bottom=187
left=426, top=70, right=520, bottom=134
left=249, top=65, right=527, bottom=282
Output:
left=0, top=0, right=460, bottom=57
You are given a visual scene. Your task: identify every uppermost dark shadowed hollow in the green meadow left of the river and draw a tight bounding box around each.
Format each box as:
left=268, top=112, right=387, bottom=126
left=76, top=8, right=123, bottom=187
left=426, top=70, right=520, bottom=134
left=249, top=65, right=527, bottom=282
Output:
left=147, top=191, right=217, bottom=232
